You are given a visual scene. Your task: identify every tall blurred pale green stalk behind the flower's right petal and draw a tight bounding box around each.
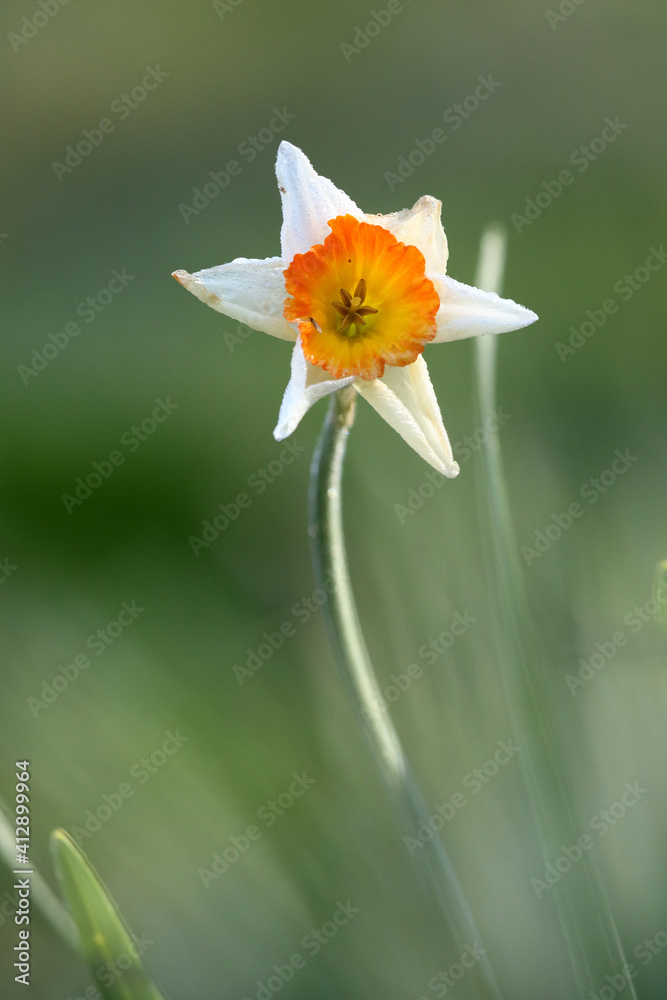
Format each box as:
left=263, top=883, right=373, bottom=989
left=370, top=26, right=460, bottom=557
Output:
left=476, top=227, right=636, bottom=998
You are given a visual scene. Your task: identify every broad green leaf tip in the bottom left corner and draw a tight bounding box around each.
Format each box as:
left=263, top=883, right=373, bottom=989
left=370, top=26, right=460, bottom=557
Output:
left=51, top=830, right=163, bottom=1000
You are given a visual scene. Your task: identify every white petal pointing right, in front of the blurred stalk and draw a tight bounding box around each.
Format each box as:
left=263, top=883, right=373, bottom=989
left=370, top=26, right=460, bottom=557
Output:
left=429, top=274, right=538, bottom=344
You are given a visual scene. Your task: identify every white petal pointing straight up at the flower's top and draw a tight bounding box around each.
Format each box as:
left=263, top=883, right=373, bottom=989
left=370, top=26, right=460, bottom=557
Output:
left=276, top=140, right=363, bottom=264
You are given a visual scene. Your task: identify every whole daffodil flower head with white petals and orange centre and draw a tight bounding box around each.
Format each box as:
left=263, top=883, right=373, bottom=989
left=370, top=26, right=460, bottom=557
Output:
left=174, top=142, right=537, bottom=477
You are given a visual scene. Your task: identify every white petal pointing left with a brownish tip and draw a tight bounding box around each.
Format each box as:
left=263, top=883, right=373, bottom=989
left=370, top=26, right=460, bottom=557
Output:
left=173, top=257, right=296, bottom=341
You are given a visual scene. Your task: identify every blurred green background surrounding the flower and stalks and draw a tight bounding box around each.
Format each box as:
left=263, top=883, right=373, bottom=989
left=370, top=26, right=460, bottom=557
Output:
left=0, top=0, right=667, bottom=1000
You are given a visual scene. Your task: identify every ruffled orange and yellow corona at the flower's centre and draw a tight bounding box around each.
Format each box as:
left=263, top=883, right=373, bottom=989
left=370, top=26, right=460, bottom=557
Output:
left=284, top=215, right=440, bottom=379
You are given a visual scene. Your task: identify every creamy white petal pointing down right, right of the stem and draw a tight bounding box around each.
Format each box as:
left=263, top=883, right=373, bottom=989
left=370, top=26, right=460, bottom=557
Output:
left=354, top=355, right=459, bottom=479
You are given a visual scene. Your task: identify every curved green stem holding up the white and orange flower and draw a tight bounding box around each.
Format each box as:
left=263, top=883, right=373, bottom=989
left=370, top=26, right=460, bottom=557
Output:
left=309, top=386, right=500, bottom=1000
